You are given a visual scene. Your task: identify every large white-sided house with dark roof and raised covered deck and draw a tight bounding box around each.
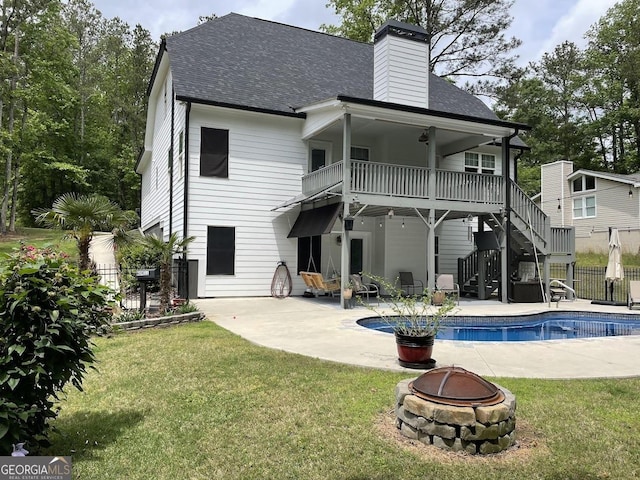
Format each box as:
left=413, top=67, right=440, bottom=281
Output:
left=136, top=14, right=570, bottom=300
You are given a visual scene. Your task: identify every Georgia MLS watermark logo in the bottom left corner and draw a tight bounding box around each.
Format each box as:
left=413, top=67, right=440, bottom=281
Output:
left=0, top=456, right=71, bottom=480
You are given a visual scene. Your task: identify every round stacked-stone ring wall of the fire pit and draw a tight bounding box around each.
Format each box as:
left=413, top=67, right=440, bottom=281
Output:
left=396, top=378, right=516, bottom=454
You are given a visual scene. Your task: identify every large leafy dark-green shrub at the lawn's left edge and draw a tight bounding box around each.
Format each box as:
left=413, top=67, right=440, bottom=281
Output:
left=0, top=246, right=112, bottom=455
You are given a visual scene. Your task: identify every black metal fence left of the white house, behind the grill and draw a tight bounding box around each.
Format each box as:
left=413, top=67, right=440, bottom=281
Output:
left=96, top=261, right=189, bottom=310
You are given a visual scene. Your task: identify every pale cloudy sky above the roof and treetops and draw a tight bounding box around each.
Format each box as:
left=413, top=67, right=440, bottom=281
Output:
left=93, top=0, right=616, bottom=65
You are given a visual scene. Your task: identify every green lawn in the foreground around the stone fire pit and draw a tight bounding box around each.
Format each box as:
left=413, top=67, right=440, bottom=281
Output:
left=47, top=322, right=640, bottom=480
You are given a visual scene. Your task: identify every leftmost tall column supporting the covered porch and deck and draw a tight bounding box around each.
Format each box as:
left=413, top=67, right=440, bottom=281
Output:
left=340, top=113, right=351, bottom=308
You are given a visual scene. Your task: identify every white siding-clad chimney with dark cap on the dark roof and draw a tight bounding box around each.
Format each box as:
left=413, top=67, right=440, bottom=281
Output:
left=373, top=20, right=429, bottom=108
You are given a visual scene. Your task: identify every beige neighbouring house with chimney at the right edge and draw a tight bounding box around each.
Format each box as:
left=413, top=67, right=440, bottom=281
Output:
left=539, top=160, right=640, bottom=253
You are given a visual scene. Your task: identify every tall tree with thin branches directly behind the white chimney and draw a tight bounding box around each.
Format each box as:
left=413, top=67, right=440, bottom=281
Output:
left=321, top=0, right=521, bottom=89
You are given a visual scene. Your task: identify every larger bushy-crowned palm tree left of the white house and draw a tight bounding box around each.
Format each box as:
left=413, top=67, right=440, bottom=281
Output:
left=31, top=193, right=138, bottom=270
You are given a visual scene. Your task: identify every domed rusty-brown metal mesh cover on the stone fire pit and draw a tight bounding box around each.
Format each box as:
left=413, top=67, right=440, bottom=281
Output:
left=409, top=367, right=504, bottom=406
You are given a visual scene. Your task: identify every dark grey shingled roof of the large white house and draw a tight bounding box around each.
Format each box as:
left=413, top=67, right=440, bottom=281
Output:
left=166, top=13, right=498, bottom=120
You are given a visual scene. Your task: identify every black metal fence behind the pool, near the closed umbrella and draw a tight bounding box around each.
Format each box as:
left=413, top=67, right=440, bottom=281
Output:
left=551, top=264, right=640, bottom=303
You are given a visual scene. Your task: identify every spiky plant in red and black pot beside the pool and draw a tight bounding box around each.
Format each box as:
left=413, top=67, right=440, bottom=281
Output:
left=363, top=276, right=455, bottom=369
